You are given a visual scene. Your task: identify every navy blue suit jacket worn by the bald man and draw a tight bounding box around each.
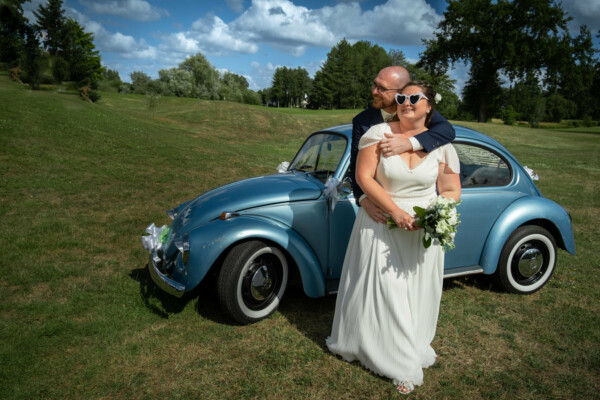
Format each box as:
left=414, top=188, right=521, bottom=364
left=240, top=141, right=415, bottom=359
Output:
left=350, top=107, right=455, bottom=205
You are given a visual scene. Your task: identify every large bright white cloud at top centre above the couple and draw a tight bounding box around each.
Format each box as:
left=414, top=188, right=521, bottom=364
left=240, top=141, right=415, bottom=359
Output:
left=215, top=0, right=441, bottom=56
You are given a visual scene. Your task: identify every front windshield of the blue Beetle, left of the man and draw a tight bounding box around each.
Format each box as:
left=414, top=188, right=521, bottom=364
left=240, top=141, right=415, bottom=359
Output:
left=289, top=133, right=347, bottom=182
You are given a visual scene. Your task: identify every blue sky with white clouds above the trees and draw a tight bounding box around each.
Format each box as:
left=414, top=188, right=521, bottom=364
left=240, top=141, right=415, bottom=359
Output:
left=23, top=0, right=600, bottom=91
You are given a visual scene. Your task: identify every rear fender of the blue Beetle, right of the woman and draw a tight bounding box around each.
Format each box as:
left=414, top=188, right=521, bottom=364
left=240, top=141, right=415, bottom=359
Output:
left=480, top=197, right=575, bottom=274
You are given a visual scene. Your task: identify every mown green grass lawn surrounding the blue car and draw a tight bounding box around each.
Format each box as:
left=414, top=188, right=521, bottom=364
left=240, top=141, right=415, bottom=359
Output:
left=0, top=73, right=600, bottom=399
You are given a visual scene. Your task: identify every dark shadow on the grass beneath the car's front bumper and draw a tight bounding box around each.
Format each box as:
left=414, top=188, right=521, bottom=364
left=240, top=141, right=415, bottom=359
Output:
left=129, top=265, right=234, bottom=325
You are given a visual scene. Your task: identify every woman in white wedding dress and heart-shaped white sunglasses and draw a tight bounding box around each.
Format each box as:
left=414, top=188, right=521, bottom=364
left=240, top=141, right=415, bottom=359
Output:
left=326, top=81, right=461, bottom=394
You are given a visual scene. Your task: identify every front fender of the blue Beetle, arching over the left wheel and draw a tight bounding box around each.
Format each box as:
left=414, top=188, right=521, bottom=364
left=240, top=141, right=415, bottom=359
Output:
left=186, top=215, right=325, bottom=297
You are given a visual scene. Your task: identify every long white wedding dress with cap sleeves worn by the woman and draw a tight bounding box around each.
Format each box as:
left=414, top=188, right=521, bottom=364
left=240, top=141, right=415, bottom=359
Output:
left=326, top=124, right=460, bottom=385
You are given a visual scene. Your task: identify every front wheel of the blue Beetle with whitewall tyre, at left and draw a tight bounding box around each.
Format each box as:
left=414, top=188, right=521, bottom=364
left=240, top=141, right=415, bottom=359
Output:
left=217, top=240, right=288, bottom=324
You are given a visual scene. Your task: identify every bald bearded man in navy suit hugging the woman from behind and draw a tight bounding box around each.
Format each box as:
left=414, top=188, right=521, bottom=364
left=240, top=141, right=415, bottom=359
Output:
left=350, top=66, right=454, bottom=224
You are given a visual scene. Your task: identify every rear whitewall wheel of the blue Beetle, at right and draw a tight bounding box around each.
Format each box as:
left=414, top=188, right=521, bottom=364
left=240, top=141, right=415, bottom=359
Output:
left=495, top=225, right=556, bottom=294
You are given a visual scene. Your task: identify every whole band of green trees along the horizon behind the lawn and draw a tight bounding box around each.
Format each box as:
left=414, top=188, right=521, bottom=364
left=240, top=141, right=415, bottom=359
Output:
left=0, top=0, right=600, bottom=126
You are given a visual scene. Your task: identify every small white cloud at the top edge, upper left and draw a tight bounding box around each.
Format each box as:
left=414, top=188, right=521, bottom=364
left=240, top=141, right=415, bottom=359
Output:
left=79, top=0, right=169, bottom=21
